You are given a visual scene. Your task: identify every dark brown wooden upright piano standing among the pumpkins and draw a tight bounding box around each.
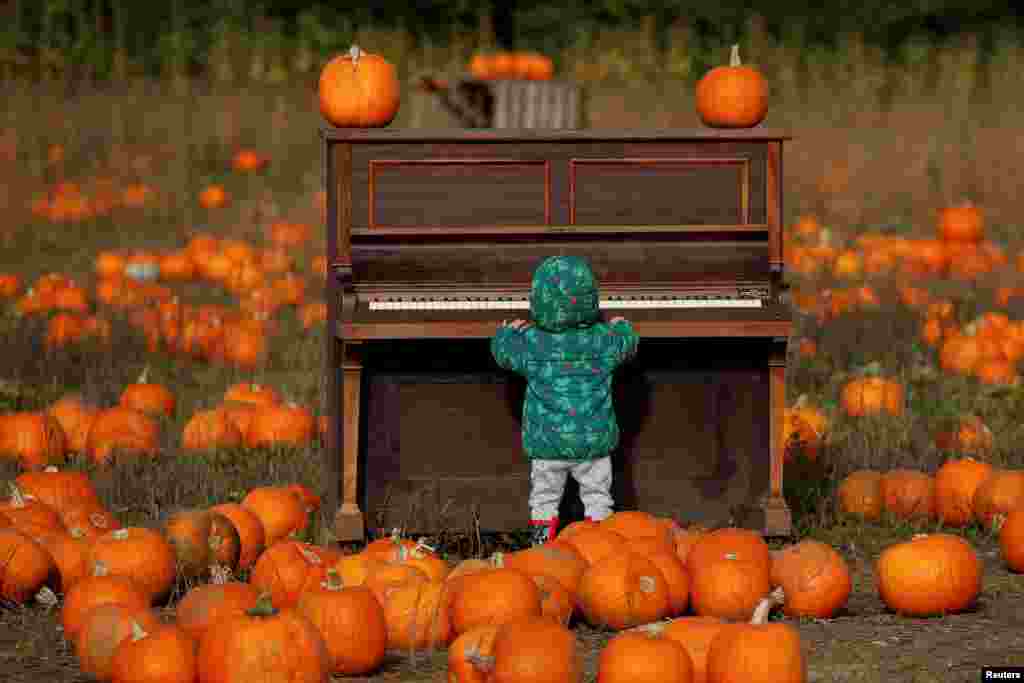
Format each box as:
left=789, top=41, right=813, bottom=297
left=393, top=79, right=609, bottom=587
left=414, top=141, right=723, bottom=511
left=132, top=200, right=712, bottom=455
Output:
left=321, top=127, right=792, bottom=542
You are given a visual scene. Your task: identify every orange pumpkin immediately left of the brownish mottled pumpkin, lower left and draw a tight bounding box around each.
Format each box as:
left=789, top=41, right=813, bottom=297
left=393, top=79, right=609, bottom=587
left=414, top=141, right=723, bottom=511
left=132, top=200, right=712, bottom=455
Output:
left=89, top=526, right=176, bottom=602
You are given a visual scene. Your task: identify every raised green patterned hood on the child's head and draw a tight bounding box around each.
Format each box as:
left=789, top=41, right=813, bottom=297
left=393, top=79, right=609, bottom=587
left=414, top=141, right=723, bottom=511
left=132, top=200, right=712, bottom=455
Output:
left=529, top=256, right=599, bottom=332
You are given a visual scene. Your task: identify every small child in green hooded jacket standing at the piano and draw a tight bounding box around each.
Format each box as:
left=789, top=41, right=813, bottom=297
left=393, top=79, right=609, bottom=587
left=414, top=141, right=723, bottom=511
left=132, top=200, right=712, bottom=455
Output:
left=490, top=256, right=639, bottom=546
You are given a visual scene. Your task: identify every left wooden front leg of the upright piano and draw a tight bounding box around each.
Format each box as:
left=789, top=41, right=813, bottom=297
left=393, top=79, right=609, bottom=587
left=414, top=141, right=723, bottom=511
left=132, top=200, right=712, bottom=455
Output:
left=334, top=342, right=366, bottom=543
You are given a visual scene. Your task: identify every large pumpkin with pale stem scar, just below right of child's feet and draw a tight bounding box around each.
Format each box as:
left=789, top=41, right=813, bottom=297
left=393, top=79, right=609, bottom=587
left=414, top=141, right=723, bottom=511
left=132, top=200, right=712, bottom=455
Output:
left=579, top=553, right=671, bottom=629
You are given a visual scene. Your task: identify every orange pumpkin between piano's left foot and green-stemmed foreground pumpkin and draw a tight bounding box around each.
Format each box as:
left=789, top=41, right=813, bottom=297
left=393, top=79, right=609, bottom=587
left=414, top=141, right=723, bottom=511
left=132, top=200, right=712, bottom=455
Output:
left=249, top=541, right=330, bottom=608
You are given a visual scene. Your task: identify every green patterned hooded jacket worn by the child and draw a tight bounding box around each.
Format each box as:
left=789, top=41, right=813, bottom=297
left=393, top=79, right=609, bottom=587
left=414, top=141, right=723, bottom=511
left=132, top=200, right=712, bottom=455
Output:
left=490, top=256, right=639, bottom=460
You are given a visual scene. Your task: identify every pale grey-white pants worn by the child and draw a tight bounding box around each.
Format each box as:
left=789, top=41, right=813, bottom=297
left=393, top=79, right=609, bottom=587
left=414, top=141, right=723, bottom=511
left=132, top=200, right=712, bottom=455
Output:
left=529, top=456, right=611, bottom=521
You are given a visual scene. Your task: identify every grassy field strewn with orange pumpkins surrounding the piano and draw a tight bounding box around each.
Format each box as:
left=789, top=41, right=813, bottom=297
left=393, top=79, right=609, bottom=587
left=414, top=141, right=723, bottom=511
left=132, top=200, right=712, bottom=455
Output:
left=0, top=13, right=1024, bottom=683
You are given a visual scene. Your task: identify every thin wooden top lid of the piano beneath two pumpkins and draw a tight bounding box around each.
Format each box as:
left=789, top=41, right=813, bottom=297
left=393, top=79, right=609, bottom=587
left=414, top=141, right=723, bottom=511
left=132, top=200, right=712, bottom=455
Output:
left=319, top=124, right=793, bottom=142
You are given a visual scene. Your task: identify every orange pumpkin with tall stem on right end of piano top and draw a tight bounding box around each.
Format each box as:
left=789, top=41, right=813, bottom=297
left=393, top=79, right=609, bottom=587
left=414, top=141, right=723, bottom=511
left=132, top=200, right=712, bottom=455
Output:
left=696, top=45, right=768, bottom=128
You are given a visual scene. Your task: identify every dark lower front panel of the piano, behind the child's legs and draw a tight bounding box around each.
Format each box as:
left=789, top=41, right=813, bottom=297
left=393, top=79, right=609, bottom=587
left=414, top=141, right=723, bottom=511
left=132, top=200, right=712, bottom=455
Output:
left=359, top=340, right=769, bottom=532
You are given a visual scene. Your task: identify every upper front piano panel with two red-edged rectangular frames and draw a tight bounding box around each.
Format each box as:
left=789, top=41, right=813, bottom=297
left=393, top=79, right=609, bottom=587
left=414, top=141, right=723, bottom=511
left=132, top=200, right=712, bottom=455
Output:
left=351, top=140, right=768, bottom=232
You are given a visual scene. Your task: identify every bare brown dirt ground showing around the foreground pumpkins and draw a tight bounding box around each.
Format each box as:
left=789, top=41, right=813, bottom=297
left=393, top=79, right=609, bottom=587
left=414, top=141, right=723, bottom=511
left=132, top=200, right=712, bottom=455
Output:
left=0, top=540, right=1024, bottom=683
